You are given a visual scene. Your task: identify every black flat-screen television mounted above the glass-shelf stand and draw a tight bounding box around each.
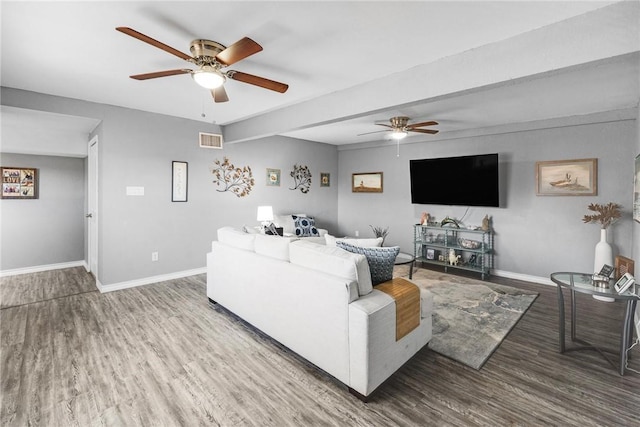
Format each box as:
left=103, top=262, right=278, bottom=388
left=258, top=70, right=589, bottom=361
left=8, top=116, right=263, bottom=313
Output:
left=409, top=153, right=500, bottom=207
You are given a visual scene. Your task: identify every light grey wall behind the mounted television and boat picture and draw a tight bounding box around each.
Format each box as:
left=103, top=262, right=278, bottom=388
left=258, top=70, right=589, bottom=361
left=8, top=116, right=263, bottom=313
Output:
left=338, top=116, right=637, bottom=278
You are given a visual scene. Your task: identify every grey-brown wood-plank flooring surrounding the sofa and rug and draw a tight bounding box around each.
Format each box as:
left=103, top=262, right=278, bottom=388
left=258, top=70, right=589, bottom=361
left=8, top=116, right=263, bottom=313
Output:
left=0, top=268, right=640, bottom=426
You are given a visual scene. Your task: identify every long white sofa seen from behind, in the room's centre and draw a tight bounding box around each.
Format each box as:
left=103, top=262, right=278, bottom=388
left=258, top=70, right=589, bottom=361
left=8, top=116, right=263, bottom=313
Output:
left=207, top=227, right=433, bottom=400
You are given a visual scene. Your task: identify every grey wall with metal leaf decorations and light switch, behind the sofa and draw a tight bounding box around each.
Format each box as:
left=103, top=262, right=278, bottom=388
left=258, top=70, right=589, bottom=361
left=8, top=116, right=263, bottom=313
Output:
left=1, top=88, right=337, bottom=285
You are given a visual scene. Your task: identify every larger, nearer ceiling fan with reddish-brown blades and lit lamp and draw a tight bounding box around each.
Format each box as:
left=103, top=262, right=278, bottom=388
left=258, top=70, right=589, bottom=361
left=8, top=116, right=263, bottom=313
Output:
left=116, top=27, right=289, bottom=102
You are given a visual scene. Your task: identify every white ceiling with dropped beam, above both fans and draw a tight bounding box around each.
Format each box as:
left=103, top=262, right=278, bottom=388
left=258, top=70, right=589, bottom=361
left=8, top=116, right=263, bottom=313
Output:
left=0, top=1, right=640, bottom=150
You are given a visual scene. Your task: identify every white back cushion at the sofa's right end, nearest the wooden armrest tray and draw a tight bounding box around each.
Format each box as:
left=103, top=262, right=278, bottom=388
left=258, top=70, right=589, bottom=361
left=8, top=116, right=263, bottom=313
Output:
left=289, top=240, right=373, bottom=296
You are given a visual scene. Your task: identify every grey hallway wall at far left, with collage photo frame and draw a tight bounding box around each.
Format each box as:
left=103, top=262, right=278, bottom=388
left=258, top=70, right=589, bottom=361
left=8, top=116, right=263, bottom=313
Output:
left=0, top=153, right=85, bottom=271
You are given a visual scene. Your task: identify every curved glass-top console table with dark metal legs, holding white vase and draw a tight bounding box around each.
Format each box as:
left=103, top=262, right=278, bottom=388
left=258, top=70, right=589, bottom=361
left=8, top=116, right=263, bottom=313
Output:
left=551, top=272, right=640, bottom=375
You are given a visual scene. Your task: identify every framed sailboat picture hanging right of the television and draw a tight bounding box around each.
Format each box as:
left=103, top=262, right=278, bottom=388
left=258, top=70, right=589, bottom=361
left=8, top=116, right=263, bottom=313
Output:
left=536, top=159, right=598, bottom=196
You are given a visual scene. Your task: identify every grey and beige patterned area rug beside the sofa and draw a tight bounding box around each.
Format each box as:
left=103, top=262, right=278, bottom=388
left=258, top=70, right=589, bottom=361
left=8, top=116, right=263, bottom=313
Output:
left=394, top=266, right=538, bottom=369
